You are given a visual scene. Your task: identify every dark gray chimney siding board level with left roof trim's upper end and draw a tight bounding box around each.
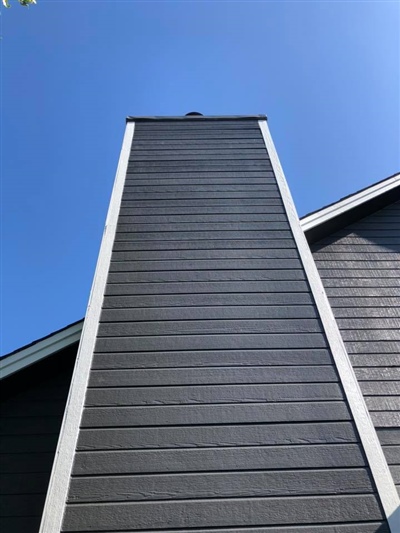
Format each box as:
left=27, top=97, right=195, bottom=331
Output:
left=97, top=318, right=321, bottom=338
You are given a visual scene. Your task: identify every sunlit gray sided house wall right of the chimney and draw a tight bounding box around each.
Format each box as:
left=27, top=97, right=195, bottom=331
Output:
left=312, top=201, right=400, bottom=491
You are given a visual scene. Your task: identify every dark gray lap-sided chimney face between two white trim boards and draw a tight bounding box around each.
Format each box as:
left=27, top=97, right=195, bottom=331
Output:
left=62, top=120, right=388, bottom=533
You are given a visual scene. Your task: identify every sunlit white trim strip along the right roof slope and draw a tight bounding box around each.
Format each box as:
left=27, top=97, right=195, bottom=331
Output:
left=300, top=173, right=400, bottom=232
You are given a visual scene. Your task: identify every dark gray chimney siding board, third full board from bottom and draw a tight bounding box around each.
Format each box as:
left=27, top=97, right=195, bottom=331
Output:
left=73, top=444, right=365, bottom=476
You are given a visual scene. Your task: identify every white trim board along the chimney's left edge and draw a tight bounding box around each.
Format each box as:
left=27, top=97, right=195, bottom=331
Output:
left=40, top=122, right=135, bottom=533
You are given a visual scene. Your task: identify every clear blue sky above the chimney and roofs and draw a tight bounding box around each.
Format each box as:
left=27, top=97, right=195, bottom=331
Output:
left=0, top=0, right=400, bottom=353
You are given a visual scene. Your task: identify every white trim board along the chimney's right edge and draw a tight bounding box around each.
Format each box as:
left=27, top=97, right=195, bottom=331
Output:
left=259, top=120, right=400, bottom=533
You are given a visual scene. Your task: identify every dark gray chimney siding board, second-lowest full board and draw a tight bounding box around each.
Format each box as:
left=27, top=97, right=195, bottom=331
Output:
left=69, top=469, right=372, bottom=503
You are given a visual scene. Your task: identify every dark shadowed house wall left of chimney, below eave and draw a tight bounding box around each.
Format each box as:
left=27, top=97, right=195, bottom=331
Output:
left=0, top=344, right=77, bottom=533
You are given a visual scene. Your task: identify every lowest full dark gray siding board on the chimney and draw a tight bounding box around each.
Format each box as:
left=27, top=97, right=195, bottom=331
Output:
left=64, top=495, right=382, bottom=531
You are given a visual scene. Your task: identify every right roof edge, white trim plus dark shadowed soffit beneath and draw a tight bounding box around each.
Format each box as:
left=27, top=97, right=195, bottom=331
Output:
left=300, top=172, right=400, bottom=242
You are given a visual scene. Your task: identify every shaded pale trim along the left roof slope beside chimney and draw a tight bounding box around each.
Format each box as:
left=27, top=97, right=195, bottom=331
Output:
left=0, top=320, right=83, bottom=379
